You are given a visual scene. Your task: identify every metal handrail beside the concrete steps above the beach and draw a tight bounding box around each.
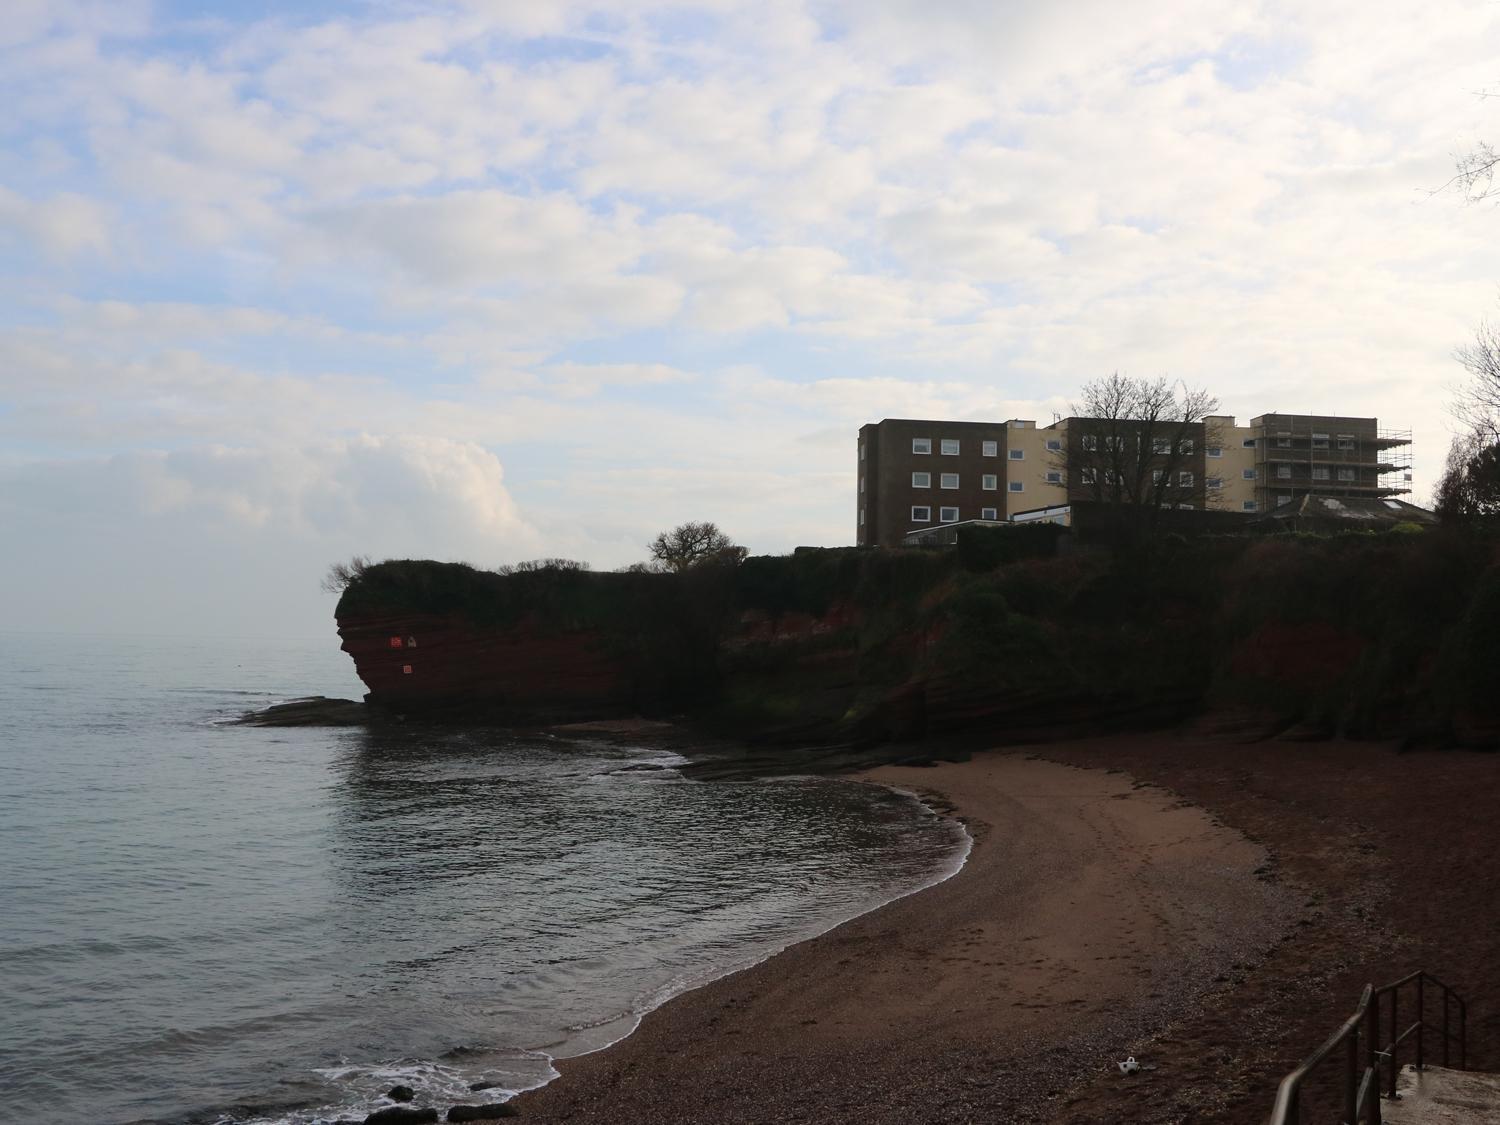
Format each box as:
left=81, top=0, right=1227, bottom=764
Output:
left=1271, top=969, right=1469, bottom=1125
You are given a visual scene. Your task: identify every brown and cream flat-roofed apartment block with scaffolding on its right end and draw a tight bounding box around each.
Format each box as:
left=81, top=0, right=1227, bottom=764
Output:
left=855, top=414, right=1412, bottom=546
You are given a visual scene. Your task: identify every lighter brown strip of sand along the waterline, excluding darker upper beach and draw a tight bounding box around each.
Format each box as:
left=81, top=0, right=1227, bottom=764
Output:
left=516, top=744, right=1301, bottom=1124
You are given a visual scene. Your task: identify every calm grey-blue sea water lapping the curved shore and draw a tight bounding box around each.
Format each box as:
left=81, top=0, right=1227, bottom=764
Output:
left=0, top=635, right=966, bottom=1124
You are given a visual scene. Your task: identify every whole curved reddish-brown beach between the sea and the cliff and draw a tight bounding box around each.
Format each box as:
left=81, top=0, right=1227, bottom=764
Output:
left=518, top=735, right=1500, bottom=1125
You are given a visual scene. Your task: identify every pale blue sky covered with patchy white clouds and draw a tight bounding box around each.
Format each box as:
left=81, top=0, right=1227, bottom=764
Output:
left=0, top=0, right=1500, bottom=638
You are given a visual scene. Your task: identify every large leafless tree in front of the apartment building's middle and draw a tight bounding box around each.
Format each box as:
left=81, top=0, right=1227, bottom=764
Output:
left=1053, top=372, right=1223, bottom=524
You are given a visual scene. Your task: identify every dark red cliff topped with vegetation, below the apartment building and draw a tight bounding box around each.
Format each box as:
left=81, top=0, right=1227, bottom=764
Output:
left=336, top=528, right=1500, bottom=744
